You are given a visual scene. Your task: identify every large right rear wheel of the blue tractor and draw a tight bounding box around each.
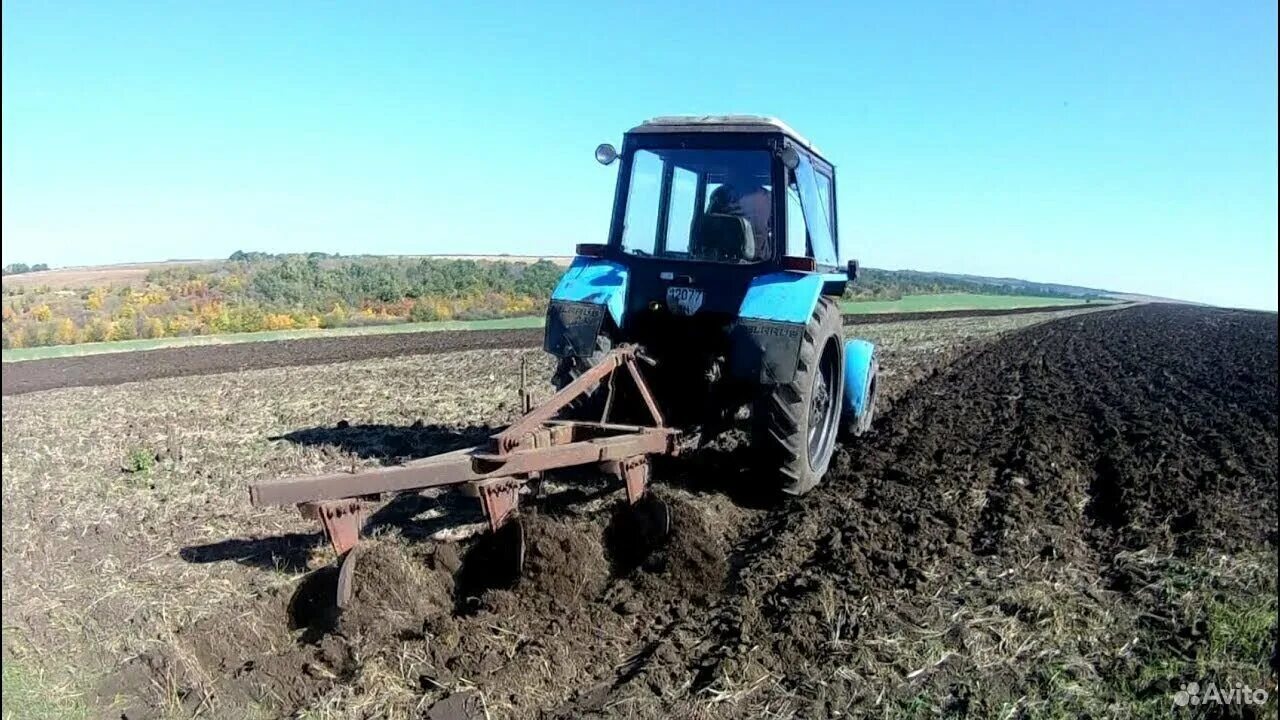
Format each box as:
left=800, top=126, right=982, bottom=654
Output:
left=751, top=297, right=845, bottom=495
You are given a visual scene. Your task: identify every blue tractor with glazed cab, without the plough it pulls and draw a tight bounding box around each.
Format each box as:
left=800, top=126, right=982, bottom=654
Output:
left=544, top=115, right=877, bottom=495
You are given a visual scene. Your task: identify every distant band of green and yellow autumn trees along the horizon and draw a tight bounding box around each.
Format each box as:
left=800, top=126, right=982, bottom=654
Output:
left=3, top=251, right=1100, bottom=347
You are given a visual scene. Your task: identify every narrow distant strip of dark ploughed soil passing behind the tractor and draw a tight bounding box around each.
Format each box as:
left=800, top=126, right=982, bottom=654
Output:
left=3, top=305, right=1097, bottom=395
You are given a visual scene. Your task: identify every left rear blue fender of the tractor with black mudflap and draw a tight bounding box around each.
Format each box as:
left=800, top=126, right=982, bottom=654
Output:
left=543, top=258, right=628, bottom=357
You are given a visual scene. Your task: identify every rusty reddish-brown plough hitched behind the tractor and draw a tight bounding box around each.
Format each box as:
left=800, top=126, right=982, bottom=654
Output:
left=250, top=345, right=680, bottom=609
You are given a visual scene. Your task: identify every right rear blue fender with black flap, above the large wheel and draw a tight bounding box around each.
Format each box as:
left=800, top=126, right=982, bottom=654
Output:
left=730, top=272, right=847, bottom=384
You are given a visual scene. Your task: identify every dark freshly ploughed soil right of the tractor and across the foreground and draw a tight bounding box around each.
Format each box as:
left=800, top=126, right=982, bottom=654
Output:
left=77, top=305, right=1277, bottom=719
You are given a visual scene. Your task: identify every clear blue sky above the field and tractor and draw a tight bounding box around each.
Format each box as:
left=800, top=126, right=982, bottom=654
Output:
left=3, top=0, right=1277, bottom=309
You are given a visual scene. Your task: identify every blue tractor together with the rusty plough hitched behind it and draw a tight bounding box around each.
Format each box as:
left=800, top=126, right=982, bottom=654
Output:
left=250, top=117, right=877, bottom=599
